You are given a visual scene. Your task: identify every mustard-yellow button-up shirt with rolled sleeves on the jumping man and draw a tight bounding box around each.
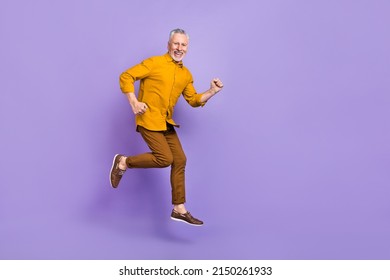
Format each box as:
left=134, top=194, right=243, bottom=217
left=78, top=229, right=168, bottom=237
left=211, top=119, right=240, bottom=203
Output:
left=120, top=53, right=205, bottom=131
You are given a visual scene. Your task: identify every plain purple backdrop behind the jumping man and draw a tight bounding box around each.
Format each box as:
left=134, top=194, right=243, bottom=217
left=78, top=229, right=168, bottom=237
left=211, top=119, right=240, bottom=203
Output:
left=0, top=0, right=390, bottom=259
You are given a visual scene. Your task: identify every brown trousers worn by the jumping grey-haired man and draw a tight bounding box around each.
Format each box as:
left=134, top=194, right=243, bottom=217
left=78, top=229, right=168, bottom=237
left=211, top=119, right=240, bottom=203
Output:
left=126, top=125, right=187, bottom=204
